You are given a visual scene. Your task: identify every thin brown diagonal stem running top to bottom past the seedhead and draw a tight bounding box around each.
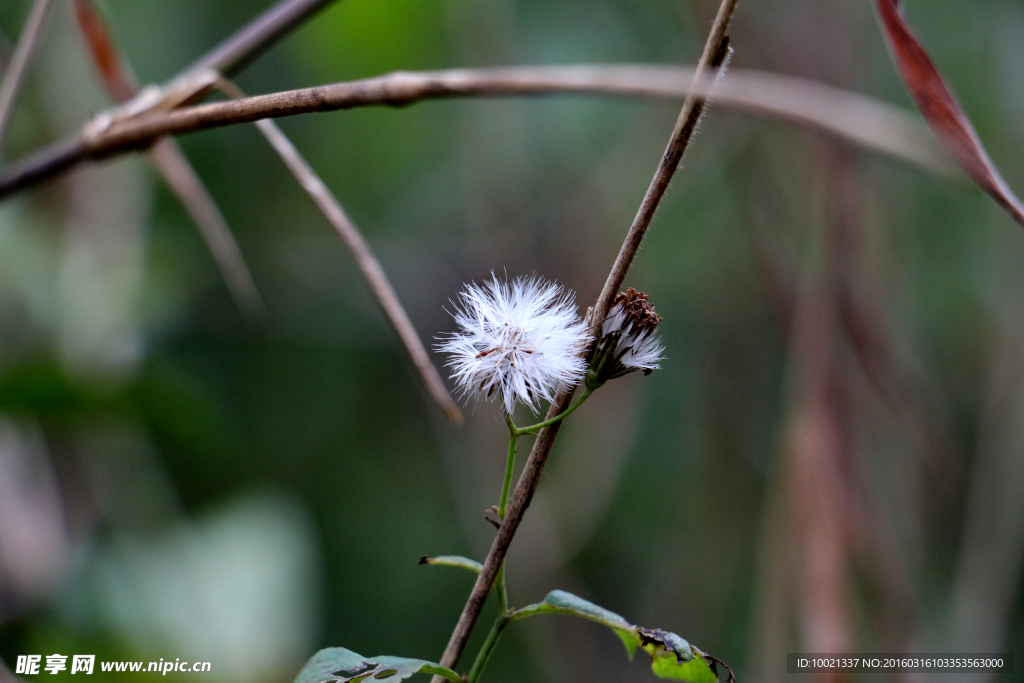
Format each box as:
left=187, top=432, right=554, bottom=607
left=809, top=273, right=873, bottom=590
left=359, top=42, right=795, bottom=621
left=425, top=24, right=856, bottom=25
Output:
left=433, top=0, right=736, bottom=683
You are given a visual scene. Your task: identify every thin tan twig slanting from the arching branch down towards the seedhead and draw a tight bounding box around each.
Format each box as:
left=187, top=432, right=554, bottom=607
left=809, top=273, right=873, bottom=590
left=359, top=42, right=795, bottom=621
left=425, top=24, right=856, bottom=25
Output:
left=217, top=79, right=462, bottom=424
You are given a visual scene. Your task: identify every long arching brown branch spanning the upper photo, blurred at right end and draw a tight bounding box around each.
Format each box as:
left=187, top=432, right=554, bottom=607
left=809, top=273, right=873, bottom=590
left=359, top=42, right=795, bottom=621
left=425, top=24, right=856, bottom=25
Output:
left=0, top=65, right=954, bottom=197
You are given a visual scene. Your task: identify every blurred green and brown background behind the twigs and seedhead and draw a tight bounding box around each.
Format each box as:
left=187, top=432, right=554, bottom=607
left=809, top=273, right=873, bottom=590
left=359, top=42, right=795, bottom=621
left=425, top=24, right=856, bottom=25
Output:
left=0, top=0, right=1024, bottom=683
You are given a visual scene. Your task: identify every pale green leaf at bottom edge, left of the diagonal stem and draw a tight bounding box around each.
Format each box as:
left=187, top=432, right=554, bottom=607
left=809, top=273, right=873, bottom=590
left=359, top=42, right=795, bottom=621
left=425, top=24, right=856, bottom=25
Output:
left=295, top=647, right=462, bottom=683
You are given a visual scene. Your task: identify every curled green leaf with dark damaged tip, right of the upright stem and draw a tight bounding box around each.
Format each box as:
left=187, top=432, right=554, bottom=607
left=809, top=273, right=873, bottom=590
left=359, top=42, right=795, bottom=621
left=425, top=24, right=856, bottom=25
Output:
left=512, top=591, right=733, bottom=683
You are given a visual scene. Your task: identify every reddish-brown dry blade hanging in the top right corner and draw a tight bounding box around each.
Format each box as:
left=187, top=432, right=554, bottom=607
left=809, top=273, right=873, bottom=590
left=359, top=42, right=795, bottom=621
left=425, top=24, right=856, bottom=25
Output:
left=876, top=0, right=1024, bottom=226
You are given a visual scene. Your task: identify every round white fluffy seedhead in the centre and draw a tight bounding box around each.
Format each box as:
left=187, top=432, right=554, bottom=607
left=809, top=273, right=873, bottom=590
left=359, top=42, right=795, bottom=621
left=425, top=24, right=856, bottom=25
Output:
left=436, top=275, right=588, bottom=415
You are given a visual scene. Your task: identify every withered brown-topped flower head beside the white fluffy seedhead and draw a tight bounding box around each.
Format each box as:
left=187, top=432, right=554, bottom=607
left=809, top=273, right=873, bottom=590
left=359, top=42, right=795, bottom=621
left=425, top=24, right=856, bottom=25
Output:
left=587, top=287, right=665, bottom=390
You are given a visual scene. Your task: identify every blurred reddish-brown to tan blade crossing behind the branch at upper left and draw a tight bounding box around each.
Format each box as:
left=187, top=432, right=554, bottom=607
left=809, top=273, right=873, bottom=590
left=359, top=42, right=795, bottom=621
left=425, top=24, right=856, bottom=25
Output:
left=74, top=0, right=263, bottom=313
